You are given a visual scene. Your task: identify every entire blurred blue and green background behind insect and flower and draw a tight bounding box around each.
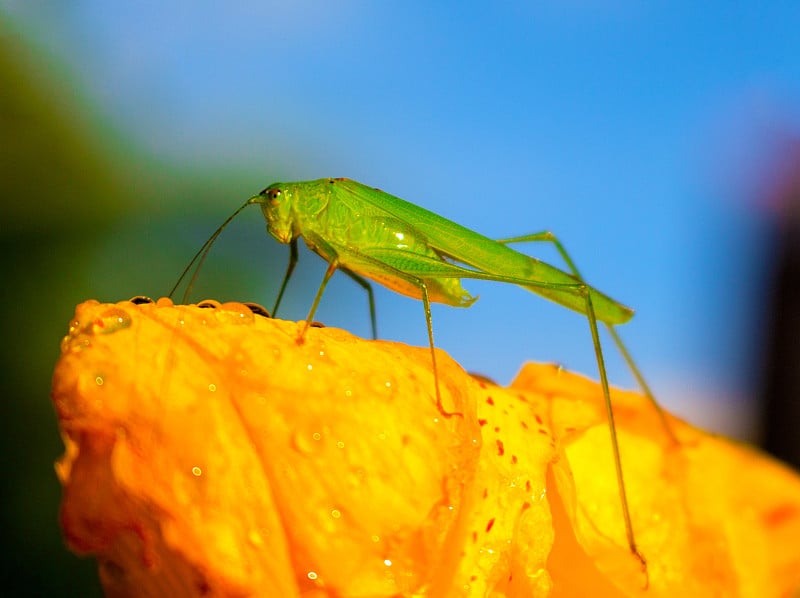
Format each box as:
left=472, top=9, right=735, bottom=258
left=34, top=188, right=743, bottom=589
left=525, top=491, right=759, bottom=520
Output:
left=0, top=0, right=800, bottom=596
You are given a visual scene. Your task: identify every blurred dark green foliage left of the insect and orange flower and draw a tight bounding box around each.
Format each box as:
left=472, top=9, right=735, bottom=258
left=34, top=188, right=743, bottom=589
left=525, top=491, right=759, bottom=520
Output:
left=0, top=15, right=285, bottom=597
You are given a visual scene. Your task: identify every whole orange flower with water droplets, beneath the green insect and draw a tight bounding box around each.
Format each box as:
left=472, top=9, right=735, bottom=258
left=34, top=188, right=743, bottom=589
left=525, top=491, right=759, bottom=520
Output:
left=53, top=300, right=800, bottom=596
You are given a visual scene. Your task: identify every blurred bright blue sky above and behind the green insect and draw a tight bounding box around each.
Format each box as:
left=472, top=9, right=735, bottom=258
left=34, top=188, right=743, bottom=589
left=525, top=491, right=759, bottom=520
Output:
left=6, top=0, right=800, bottom=438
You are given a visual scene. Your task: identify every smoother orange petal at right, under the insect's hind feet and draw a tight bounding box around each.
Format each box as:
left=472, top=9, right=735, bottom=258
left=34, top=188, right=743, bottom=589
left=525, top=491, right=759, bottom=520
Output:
left=512, top=364, right=800, bottom=597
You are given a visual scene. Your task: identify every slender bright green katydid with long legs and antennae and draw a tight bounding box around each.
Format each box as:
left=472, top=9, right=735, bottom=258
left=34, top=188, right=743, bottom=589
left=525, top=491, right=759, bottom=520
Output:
left=170, top=178, right=677, bottom=571
